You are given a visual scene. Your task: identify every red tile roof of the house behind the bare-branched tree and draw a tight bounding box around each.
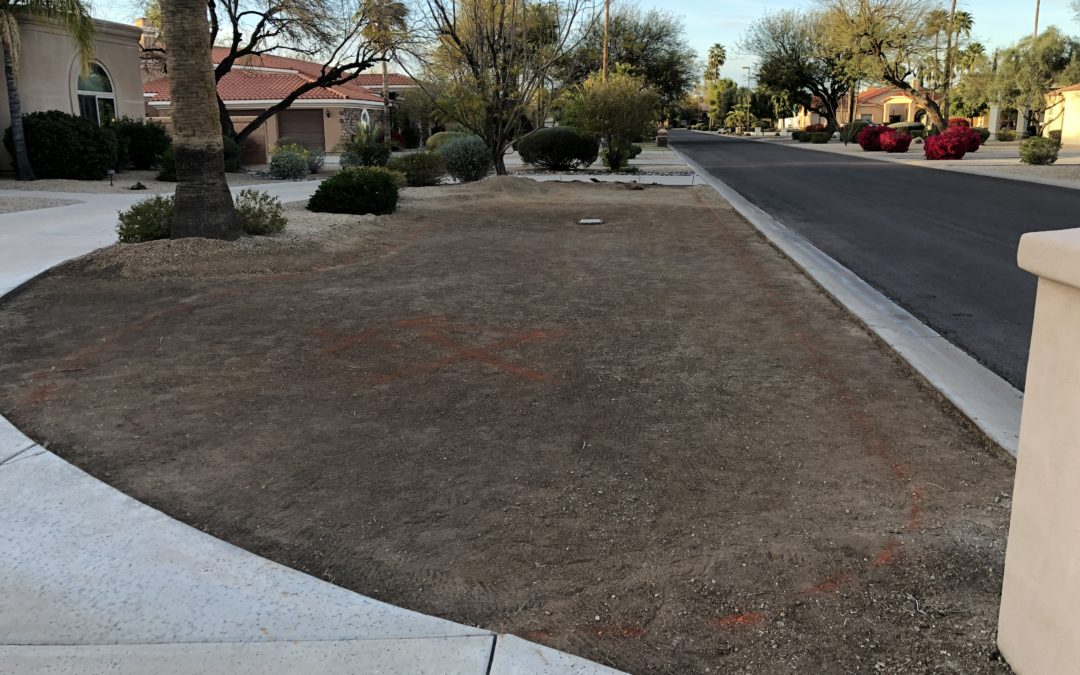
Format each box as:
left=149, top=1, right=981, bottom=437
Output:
left=143, top=46, right=413, bottom=103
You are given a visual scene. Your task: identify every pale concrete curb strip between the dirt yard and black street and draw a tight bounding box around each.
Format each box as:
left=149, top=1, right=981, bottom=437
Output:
left=672, top=142, right=1024, bottom=457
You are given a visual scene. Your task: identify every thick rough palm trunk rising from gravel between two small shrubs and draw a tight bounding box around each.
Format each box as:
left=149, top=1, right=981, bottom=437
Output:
left=161, top=0, right=243, bottom=239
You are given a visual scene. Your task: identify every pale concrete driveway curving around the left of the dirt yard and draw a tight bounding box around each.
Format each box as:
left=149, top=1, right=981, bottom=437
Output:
left=0, top=181, right=617, bottom=675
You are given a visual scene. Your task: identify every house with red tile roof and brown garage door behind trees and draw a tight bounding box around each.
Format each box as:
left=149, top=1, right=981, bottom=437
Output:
left=144, top=48, right=416, bottom=162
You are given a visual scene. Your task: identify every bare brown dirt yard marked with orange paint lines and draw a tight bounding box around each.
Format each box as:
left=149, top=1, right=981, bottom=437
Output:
left=0, top=178, right=1012, bottom=673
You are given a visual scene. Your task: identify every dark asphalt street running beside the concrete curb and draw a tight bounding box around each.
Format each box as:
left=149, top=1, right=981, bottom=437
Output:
left=672, top=132, right=1080, bottom=390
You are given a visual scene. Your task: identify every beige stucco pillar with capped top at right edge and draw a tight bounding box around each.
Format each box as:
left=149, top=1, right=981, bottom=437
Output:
left=998, top=229, right=1080, bottom=675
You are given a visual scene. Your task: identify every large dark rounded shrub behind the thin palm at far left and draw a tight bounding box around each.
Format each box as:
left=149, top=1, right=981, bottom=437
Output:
left=3, top=110, right=117, bottom=180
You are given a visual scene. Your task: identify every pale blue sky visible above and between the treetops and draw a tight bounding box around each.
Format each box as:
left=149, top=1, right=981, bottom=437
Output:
left=93, top=0, right=1080, bottom=82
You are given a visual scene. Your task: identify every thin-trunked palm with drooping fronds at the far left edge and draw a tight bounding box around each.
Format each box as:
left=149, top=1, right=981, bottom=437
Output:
left=0, top=0, right=94, bottom=180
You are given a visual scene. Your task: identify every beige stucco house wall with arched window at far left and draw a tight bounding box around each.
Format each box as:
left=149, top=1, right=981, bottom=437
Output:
left=0, top=18, right=144, bottom=171
